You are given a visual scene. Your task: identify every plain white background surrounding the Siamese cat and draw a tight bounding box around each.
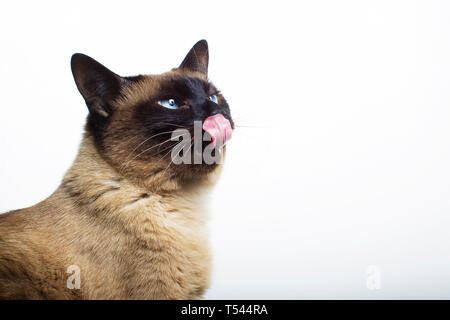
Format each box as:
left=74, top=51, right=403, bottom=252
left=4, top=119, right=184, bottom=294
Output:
left=0, top=0, right=450, bottom=299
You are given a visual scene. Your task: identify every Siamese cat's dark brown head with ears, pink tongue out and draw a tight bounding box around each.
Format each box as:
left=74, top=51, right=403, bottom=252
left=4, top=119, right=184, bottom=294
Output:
left=71, top=40, right=234, bottom=189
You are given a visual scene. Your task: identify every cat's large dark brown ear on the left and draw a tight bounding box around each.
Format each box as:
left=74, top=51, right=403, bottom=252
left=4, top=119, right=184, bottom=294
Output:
left=71, top=53, right=126, bottom=117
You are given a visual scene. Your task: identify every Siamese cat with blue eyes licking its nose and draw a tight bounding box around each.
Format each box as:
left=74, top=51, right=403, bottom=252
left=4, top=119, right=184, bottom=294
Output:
left=0, top=40, right=234, bottom=299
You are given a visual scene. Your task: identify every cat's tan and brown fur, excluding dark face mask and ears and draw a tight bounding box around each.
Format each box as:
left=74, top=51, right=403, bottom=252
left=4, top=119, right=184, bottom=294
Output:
left=0, top=41, right=230, bottom=299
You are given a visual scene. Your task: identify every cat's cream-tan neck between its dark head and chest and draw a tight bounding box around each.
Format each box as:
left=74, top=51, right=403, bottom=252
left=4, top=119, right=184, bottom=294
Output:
left=57, top=135, right=209, bottom=219
